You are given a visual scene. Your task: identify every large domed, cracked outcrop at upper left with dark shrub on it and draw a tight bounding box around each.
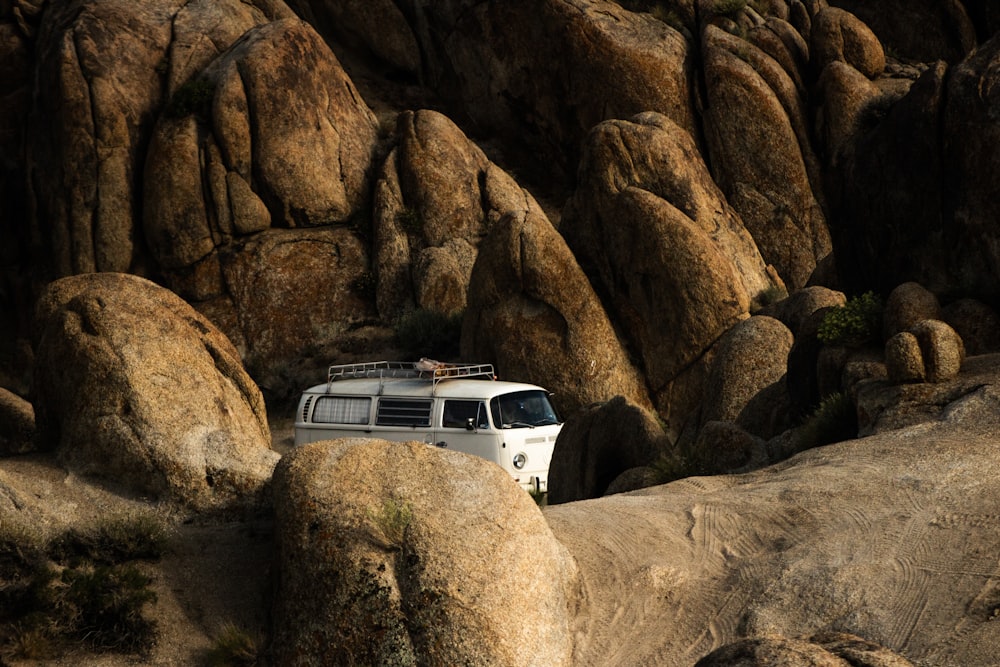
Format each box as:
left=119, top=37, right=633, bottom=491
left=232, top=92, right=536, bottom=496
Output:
left=143, top=19, right=376, bottom=284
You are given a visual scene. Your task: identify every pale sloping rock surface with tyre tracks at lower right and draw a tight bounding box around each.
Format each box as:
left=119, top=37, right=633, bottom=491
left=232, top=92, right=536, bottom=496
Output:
left=545, top=368, right=1000, bottom=665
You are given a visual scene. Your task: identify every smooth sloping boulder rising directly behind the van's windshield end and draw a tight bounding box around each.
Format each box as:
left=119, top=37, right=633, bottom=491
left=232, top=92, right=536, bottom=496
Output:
left=461, top=199, right=651, bottom=417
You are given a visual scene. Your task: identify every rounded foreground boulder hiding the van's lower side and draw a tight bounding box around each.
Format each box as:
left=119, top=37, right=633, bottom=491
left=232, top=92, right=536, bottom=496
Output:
left=273, top=439, right=579, bottom=667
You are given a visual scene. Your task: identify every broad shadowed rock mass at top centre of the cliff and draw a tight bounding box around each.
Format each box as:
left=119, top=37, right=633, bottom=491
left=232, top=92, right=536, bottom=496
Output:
left=304, top=0, right=695, bottom=183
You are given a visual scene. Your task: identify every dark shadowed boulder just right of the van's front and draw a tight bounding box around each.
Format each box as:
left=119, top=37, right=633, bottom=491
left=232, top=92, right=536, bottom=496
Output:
left=548, top=396, right=671, bottom=504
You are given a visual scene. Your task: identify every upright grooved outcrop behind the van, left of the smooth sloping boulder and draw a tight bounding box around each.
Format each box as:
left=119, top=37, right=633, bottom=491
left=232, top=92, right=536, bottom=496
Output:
left=373, top=110, right=535, bottom=321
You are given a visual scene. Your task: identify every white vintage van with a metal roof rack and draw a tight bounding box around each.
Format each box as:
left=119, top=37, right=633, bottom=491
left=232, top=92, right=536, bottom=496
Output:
left=295, top=359, right=562, bottom=493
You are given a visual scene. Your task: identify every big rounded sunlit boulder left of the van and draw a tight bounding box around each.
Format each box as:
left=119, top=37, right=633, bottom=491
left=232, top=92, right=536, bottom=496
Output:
left=35, top=273, right=279, bottom=509
